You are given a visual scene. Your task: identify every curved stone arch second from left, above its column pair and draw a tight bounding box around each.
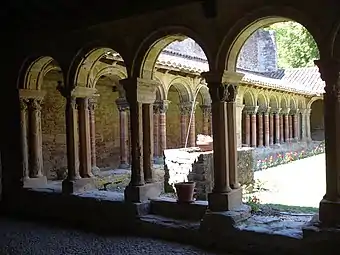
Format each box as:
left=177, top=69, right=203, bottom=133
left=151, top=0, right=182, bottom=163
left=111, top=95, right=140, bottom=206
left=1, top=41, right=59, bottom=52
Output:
left=68, top=47, right=128, bottom=88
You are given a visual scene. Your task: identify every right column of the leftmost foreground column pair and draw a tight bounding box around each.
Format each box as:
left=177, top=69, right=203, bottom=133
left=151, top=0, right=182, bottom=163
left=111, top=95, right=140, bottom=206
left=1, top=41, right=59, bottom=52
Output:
left=29, top=99, right=43, bottom=178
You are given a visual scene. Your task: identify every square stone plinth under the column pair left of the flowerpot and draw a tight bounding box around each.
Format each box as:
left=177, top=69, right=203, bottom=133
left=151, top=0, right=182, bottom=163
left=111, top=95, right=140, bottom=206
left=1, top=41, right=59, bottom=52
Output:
left=124, top=182, right=162, bottom=203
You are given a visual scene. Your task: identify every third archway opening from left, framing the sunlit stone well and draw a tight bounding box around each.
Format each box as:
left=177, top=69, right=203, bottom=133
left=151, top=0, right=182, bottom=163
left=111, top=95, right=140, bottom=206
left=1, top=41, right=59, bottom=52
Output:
left=140, top=35, right=212, bottom=197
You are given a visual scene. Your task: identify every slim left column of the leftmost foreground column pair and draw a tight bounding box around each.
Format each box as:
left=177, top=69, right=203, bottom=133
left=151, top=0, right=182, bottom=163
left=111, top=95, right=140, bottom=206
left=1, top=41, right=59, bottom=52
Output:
left=20, top=98, right=29, bottom=180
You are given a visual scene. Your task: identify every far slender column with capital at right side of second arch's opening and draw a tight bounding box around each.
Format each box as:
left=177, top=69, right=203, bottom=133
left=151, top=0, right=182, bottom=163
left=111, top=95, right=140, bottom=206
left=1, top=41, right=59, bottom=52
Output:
left=116, top=98, right=130, bottom=169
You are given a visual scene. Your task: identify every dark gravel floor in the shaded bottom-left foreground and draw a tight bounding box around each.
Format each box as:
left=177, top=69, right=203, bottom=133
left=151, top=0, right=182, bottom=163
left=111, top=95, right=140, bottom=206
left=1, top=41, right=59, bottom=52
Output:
left=0, top=218, right=226, bottom=255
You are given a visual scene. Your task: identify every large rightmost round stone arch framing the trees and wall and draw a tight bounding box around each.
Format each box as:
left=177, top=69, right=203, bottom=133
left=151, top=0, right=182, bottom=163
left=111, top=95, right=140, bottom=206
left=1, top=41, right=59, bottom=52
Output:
left=216, top=6, right=323, bottom=71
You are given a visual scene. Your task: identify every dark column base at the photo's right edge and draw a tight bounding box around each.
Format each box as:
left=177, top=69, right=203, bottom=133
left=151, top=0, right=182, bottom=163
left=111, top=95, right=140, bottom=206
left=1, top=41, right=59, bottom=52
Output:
left=319, top=199, right=340, bottom=226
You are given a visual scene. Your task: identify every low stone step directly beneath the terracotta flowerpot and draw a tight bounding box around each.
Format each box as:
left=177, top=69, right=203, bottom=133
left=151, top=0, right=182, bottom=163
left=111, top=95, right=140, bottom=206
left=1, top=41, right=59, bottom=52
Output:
left=150, top=198, right=208, bottom=221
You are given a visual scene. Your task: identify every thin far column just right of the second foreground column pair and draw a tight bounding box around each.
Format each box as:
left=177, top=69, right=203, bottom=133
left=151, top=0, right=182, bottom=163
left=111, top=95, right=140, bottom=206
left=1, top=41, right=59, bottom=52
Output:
left=89, top=97, right=100, bottom=173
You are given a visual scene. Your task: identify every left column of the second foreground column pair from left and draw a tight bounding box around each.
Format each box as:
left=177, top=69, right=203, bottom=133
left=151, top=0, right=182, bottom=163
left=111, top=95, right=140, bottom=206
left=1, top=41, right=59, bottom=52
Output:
left=63, top=97, right=80, bottom=182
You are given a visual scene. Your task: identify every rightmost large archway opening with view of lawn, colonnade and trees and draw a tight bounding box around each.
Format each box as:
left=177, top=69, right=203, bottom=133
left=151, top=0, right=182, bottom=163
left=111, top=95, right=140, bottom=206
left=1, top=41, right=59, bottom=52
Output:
left=230, top=17, right=325, bottom=215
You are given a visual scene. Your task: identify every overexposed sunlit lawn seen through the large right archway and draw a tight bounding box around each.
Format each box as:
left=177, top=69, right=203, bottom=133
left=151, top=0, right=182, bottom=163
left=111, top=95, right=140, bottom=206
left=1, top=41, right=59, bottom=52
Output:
left=255, top=153, right=326, bottom=207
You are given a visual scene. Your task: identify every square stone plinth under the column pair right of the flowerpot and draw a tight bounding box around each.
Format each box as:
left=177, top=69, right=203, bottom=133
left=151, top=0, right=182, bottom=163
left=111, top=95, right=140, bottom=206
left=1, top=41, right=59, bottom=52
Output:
left=208, top=188, right=242, bottom=212
